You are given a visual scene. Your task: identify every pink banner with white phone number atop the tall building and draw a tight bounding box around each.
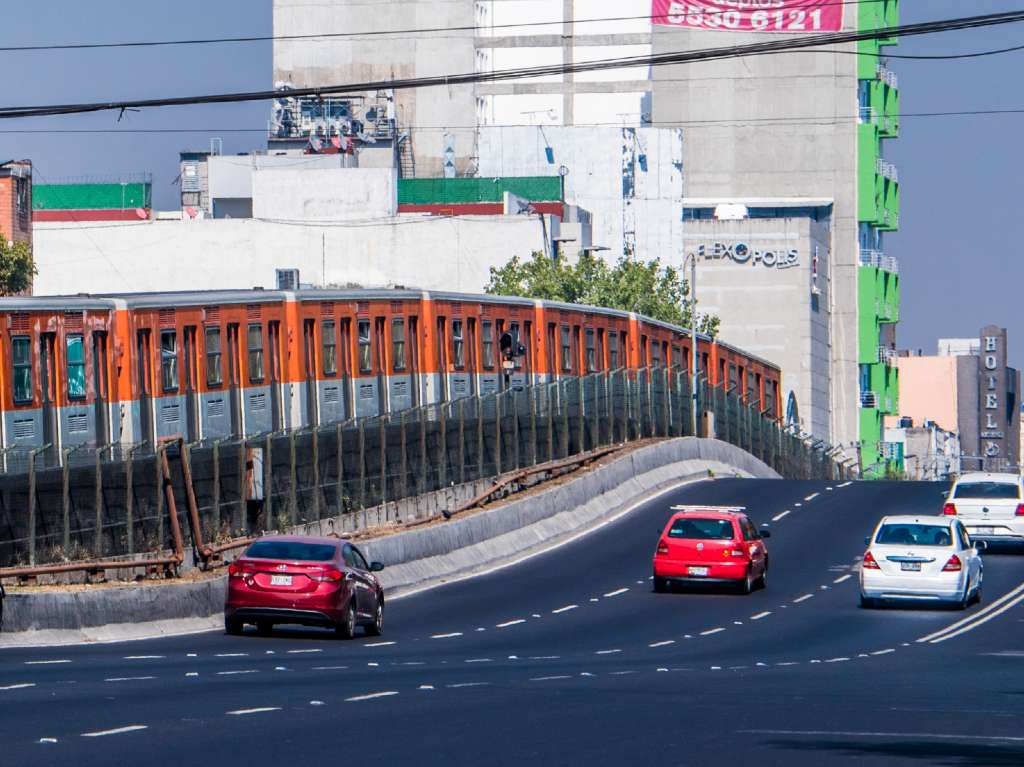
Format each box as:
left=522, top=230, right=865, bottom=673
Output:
left=651, top=0, right=843, bottom=34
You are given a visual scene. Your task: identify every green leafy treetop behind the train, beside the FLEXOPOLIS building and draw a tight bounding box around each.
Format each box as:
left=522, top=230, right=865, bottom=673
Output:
left=486, top=251, right=719, bottom=337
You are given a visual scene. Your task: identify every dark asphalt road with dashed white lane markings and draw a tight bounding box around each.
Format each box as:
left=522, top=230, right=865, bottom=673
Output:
left=0, top=479, right=1024, bottom=767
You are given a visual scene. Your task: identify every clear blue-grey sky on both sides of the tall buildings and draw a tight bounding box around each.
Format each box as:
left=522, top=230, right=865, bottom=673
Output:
left=0, top=0, right=1024, bottom=367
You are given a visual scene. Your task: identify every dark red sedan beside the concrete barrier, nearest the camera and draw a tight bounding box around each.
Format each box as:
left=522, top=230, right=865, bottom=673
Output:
left=224, top=536, right=384, bottom=638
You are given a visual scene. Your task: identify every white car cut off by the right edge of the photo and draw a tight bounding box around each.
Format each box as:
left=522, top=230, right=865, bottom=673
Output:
left=942, top=471, right=1024, bottom=545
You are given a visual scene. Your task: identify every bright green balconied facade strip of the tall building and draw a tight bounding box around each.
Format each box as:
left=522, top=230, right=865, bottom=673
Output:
left=857, top=0, right=903, bottom=477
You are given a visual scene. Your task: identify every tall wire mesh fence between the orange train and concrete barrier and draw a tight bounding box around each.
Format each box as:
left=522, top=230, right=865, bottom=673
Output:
left=0, top=369, right=850, bottom=567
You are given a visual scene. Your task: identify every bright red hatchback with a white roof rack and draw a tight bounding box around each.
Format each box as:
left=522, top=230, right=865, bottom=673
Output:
left=654, top=506, right=771, bottom=594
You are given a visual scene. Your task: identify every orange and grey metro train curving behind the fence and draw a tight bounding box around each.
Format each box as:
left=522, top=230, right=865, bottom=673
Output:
left=0, top=289, right=780, bottom=449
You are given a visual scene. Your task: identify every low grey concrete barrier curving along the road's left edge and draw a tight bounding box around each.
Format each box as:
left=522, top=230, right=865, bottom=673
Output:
left=0, top=437, right=778, bottom=646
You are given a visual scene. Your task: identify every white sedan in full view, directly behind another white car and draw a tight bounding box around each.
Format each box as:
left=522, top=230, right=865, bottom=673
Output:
left=860, top=516, right=985, bottom=609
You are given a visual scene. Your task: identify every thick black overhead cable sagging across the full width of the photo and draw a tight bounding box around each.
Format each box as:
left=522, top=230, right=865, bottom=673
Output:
left=0, top=10, right=1024, bottom=119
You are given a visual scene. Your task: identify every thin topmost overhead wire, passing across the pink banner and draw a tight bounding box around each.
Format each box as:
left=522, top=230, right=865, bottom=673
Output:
left=0, top=0, right=889, bottom=53
